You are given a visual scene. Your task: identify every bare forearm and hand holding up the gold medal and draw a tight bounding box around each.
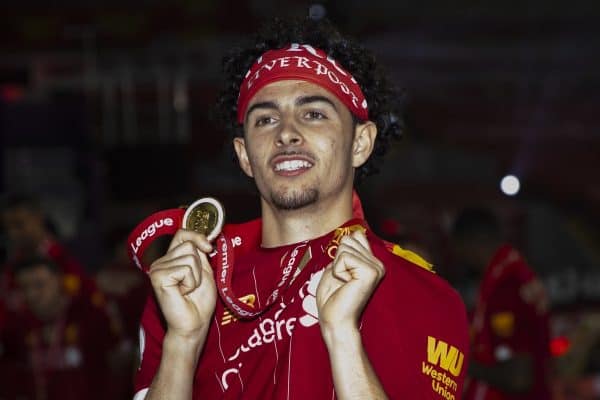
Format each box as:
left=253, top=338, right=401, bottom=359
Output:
left=146, top=229, right=217, bottom=400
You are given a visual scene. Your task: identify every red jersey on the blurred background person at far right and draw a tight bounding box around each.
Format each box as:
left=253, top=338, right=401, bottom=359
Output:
left=465, top=245, right=551, bottom=400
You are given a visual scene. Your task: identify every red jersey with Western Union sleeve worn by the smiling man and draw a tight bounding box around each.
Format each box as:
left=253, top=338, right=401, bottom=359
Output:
left=135, top=220, right=468, bottom=400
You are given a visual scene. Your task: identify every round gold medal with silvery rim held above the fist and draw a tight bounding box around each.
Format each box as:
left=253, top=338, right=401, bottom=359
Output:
left=182, top=197, right=225, bottom=241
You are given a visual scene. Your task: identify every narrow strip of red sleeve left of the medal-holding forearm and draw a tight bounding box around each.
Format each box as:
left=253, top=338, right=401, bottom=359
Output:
left=134, top=295, right=165, bottom=400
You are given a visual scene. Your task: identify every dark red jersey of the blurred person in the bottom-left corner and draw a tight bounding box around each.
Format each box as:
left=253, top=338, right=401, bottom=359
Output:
left=0, top=290, right=117, bottom=400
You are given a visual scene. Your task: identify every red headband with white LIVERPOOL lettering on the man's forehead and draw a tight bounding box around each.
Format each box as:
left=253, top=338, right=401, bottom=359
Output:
left=237, top=43, right=369, bottom=124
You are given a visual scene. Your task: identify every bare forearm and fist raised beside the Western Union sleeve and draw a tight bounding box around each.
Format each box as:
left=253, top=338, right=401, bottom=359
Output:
left=317, top=232, right=388, bottom=400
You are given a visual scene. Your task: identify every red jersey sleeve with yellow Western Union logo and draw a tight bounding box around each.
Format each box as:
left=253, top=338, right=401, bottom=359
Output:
left=361, top=245, right=469, bottom=400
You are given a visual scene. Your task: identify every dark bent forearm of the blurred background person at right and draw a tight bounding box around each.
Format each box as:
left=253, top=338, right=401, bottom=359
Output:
left=469, top=354, right=533, bottom=393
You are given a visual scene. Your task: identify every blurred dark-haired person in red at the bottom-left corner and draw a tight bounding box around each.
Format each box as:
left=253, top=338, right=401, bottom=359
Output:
left=0, top=258, right=117, bottom=400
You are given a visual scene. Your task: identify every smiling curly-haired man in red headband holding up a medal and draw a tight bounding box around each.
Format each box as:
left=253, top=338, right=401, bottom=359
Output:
left=135, top=16, right=468, bottom=400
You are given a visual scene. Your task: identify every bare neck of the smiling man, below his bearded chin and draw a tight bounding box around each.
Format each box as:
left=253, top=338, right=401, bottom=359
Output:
left=261, top=189, right=352, bottom=247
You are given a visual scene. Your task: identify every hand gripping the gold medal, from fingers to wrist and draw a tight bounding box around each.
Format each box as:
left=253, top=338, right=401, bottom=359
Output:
left=149, top=229, right=217, bottom=339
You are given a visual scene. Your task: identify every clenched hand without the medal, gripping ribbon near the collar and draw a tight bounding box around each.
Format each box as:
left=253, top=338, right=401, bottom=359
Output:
left=316, top=231, right=385, bottom=334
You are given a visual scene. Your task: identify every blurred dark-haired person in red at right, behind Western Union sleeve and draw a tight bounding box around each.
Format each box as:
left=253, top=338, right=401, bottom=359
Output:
left=452, top=208, right=551, bottom=400
